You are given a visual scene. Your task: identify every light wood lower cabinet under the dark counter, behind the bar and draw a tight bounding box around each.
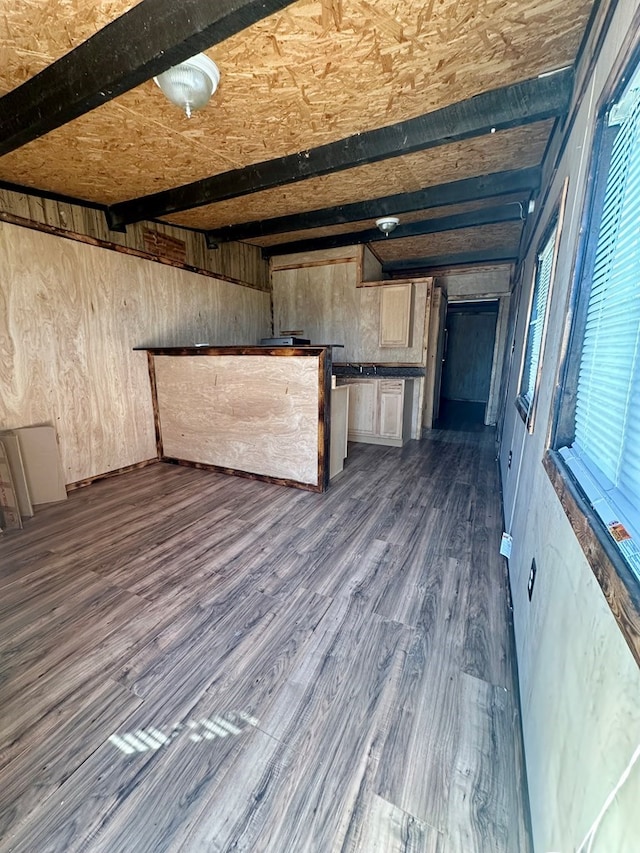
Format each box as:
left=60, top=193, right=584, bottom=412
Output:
left=339, top=376, right=413, bottom=447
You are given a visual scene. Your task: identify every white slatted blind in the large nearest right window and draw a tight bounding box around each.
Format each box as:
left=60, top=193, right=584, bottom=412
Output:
left=575, top=90, right=640, bottom=522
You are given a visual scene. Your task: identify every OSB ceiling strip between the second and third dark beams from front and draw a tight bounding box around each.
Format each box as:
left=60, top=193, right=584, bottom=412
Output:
left=166, top=121, right=553, bottom=229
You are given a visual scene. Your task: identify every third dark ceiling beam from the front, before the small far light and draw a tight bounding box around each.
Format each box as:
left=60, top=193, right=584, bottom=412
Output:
left=205, top=167, right=541, bottom=248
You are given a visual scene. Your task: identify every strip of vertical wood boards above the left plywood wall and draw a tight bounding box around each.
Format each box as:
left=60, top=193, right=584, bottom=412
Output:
left=0, top=189, right=269, bottom=290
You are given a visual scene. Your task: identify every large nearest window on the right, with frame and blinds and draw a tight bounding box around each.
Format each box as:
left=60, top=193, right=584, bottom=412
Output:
left=556, top=58, right=640, bottom=580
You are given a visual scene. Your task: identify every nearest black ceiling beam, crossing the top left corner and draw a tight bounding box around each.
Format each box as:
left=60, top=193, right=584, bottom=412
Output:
left=0, top=0, right=293, bottom=156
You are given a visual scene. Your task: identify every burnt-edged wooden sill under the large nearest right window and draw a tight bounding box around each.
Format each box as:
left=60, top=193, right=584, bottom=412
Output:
left=542, top=450, right=640, bottom=666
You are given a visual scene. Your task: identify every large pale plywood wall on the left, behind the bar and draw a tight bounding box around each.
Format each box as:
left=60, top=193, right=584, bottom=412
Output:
left=0, top=222, right=270, bottom=483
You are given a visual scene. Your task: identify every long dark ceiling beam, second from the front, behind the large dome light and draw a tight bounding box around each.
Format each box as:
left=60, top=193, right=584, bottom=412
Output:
left=109, top=68, right=573, bottom=228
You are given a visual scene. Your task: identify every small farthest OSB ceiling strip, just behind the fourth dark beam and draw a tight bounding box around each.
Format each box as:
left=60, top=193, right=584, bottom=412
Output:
left=372, top=222, right=522, bottom=263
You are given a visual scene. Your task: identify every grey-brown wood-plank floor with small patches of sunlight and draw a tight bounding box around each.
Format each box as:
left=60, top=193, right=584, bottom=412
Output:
left=0, top=432, right=530, bottom=853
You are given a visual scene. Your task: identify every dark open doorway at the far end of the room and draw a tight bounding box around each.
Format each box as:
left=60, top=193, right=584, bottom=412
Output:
left=437, top=300, right=499, bottom=429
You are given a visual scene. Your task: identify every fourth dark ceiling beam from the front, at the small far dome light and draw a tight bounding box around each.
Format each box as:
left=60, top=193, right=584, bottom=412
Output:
left=262, top=199, right=527, bottom=258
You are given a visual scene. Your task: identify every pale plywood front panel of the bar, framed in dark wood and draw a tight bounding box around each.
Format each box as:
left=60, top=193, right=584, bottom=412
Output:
left=154, top=355, right=319, bottom=485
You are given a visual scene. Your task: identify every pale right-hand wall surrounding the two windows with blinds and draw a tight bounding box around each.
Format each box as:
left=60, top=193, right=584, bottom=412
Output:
left=500, top=0, right=640, bottom=853
